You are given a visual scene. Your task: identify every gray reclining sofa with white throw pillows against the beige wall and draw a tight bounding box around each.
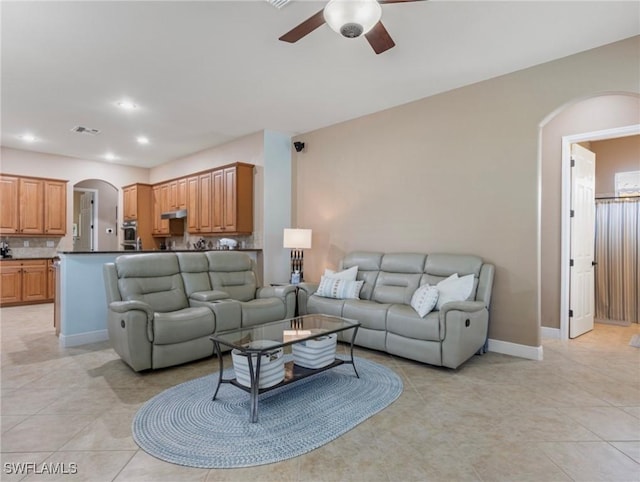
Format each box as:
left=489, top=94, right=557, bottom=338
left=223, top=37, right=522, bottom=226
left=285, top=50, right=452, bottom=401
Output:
left=298, top=252, right=494, bottom=368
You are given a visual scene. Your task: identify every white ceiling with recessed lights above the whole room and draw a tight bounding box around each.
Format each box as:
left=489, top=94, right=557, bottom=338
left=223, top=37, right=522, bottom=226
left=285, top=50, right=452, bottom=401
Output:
left=1, top=0, right=640, bottom=167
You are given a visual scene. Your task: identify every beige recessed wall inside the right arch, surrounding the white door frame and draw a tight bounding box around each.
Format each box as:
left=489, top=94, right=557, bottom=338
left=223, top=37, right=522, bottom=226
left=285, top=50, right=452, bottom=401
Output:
left=541, top=94, right=640, bottom=328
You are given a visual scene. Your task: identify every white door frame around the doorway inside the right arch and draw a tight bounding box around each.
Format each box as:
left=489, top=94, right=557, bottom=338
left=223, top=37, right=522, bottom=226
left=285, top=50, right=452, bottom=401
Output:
left=560, top=124, right=640, bottom=340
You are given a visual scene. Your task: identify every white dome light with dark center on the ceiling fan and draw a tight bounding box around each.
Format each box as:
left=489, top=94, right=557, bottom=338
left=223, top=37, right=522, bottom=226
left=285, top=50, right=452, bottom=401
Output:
left=324, top=0, right=382, bottom=38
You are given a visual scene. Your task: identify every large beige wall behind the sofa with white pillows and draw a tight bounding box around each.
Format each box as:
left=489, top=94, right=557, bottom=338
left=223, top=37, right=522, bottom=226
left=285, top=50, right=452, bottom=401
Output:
left=294, top=37, right=640, bottom=346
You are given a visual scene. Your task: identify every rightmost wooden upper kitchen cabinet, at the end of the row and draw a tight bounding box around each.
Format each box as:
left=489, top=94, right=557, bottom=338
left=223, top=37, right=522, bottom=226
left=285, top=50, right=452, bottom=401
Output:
left=211, top=163, right=254, bottom=235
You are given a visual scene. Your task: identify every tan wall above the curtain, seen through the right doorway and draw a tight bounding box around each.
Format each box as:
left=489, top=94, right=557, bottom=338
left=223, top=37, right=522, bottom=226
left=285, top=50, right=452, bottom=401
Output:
left=591, top=134, right=640, bottom=197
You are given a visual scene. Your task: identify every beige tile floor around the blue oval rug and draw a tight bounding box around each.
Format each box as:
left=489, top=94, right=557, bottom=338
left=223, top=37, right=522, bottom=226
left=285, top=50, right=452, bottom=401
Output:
left=0, top=305, right=640, bottom=482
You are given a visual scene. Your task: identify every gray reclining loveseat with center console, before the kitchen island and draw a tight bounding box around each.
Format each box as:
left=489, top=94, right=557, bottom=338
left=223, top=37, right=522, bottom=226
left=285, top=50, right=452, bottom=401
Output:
left=103, top=251, right=295, bottom=371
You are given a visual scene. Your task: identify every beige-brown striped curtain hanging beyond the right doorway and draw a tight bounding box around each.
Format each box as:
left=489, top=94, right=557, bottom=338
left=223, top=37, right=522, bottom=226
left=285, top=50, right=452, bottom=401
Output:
left=595, top=198, right=640, bottom=323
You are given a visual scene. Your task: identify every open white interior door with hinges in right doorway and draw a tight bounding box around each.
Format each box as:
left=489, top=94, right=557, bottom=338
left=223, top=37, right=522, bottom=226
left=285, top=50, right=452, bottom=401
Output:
left=569, top=144, right=596, bottom=338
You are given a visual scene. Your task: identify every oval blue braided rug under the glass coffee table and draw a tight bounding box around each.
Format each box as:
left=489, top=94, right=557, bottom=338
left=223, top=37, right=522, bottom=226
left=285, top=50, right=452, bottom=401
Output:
left=132, top=358, right=403, bottom=468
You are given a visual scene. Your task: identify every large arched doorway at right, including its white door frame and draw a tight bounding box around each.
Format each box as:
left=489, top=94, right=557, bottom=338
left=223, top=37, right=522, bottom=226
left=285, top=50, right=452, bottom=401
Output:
left=539, top=93, right=640, bottom=339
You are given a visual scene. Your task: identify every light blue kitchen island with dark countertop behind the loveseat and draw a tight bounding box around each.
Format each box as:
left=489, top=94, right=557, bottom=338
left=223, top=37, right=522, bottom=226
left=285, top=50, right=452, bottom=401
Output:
left=54, top=248, right=262, bottom=347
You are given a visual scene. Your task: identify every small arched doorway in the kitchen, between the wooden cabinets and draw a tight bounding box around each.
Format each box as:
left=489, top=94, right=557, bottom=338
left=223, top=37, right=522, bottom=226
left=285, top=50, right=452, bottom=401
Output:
left=72, top=179, right=118, bottom=251
